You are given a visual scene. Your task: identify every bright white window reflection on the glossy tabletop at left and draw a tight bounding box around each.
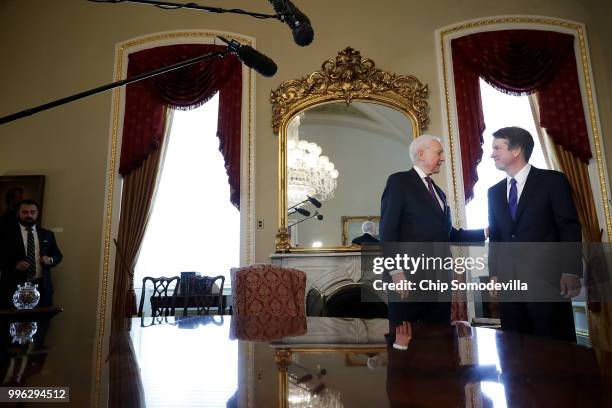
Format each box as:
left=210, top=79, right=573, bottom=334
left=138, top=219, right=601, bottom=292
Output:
left=131, top=316, right=238, bottom=407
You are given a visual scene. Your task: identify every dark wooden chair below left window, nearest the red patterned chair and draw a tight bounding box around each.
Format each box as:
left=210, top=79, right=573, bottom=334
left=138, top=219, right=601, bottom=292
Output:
left=181, top=275, right=225, bottom=316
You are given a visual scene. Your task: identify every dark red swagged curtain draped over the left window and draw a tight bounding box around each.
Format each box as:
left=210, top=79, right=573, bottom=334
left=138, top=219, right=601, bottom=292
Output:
left=119, top=44, right=242, bottom=209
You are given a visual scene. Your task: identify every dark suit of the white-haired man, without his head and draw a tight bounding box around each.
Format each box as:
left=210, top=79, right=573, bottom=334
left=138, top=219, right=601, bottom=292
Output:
left=380, top=168, right=485, bottom=323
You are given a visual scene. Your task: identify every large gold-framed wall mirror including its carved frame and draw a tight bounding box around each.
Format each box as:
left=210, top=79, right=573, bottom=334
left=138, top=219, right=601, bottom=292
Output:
left=271, top=48, right=429, bottom=252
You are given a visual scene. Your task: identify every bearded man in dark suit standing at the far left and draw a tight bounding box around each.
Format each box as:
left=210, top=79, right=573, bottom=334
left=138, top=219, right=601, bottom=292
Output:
left=0, top=200, right=62, bottom=307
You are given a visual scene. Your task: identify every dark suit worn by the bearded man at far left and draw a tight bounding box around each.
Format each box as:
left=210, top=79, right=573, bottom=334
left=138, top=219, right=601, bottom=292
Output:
left=0, top=225, right=62, bottom=307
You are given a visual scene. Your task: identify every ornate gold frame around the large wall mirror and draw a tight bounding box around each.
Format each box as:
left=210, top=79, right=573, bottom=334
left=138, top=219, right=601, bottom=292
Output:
left=270, top=47, right=429, bottom=252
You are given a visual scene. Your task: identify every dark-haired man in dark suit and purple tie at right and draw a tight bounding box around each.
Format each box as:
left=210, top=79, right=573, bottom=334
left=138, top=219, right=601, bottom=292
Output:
left=488, top=127, right=582, bottom=342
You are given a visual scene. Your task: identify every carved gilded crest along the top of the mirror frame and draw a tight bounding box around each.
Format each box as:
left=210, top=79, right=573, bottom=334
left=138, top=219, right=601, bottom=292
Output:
left=270, top=47, right=429, bottom=132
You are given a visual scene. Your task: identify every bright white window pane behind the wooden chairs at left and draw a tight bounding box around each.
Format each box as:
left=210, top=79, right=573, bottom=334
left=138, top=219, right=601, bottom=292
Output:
left=134, top=94, right=240, bottom=288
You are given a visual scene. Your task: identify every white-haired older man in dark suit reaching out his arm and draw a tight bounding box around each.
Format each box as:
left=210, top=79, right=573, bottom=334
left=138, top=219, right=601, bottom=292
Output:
left=380, top=135, right=485, bottom=330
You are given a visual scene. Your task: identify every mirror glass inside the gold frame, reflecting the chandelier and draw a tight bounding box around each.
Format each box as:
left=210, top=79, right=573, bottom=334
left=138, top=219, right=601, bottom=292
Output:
left=287, top=101, right=414, bottom=248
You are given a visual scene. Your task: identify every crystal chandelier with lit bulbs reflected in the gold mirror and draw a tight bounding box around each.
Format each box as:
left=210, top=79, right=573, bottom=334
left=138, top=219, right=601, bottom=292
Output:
left=287, top=115, right=338, bottom=207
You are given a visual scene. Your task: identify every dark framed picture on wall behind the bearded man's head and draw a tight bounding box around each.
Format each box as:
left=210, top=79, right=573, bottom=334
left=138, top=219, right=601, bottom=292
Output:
left=0, top=176, right=45, bottom=224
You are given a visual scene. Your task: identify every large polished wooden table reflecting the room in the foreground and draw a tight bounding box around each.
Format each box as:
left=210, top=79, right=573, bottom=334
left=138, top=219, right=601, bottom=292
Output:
left=0, top=313, right=612, bottom=408
